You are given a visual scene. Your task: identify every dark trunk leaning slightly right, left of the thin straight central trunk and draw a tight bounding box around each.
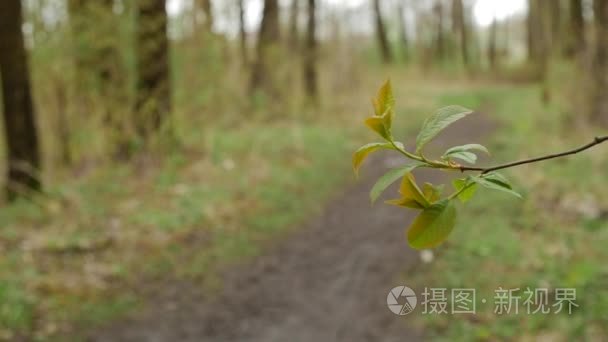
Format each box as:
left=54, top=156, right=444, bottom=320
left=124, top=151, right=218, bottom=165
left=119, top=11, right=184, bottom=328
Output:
left=251, top=0, right=280, bottom=92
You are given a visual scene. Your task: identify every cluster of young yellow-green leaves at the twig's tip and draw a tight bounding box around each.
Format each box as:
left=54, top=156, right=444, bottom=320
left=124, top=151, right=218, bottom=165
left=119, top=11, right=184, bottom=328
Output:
left=353, top=81, right=521, bottom=249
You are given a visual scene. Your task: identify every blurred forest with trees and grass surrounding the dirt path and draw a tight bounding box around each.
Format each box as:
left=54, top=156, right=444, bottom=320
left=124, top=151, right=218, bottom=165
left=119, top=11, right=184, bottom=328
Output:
left=0, top=0, right=608, bottom=341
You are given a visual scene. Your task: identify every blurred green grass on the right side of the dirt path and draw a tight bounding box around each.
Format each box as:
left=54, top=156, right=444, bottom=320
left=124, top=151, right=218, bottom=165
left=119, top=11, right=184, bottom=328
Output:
left=407, top=71, right=608, bottom=341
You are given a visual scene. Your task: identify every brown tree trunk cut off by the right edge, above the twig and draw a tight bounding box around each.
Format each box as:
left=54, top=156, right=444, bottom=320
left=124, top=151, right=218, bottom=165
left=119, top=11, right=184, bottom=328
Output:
left=591, top=0, right=608, bottom=127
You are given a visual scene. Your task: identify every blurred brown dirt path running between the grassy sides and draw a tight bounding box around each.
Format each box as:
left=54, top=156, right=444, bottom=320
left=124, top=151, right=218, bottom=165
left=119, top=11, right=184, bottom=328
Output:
left=90, top=117, right=489, bottom=342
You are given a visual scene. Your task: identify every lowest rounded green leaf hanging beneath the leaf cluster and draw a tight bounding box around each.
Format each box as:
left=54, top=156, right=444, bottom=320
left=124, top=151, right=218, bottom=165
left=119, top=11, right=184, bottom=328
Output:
left=407, top=199, right=456, bottom=249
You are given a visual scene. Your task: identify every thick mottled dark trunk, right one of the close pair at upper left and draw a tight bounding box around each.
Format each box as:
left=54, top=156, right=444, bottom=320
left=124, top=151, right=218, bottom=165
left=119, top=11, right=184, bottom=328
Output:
left=135, top=0, right=171, bottom=140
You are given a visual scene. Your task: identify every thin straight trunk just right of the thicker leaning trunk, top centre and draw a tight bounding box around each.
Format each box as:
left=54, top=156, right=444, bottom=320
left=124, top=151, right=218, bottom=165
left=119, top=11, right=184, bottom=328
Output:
left=304, top=0, right=318, bottom=104
